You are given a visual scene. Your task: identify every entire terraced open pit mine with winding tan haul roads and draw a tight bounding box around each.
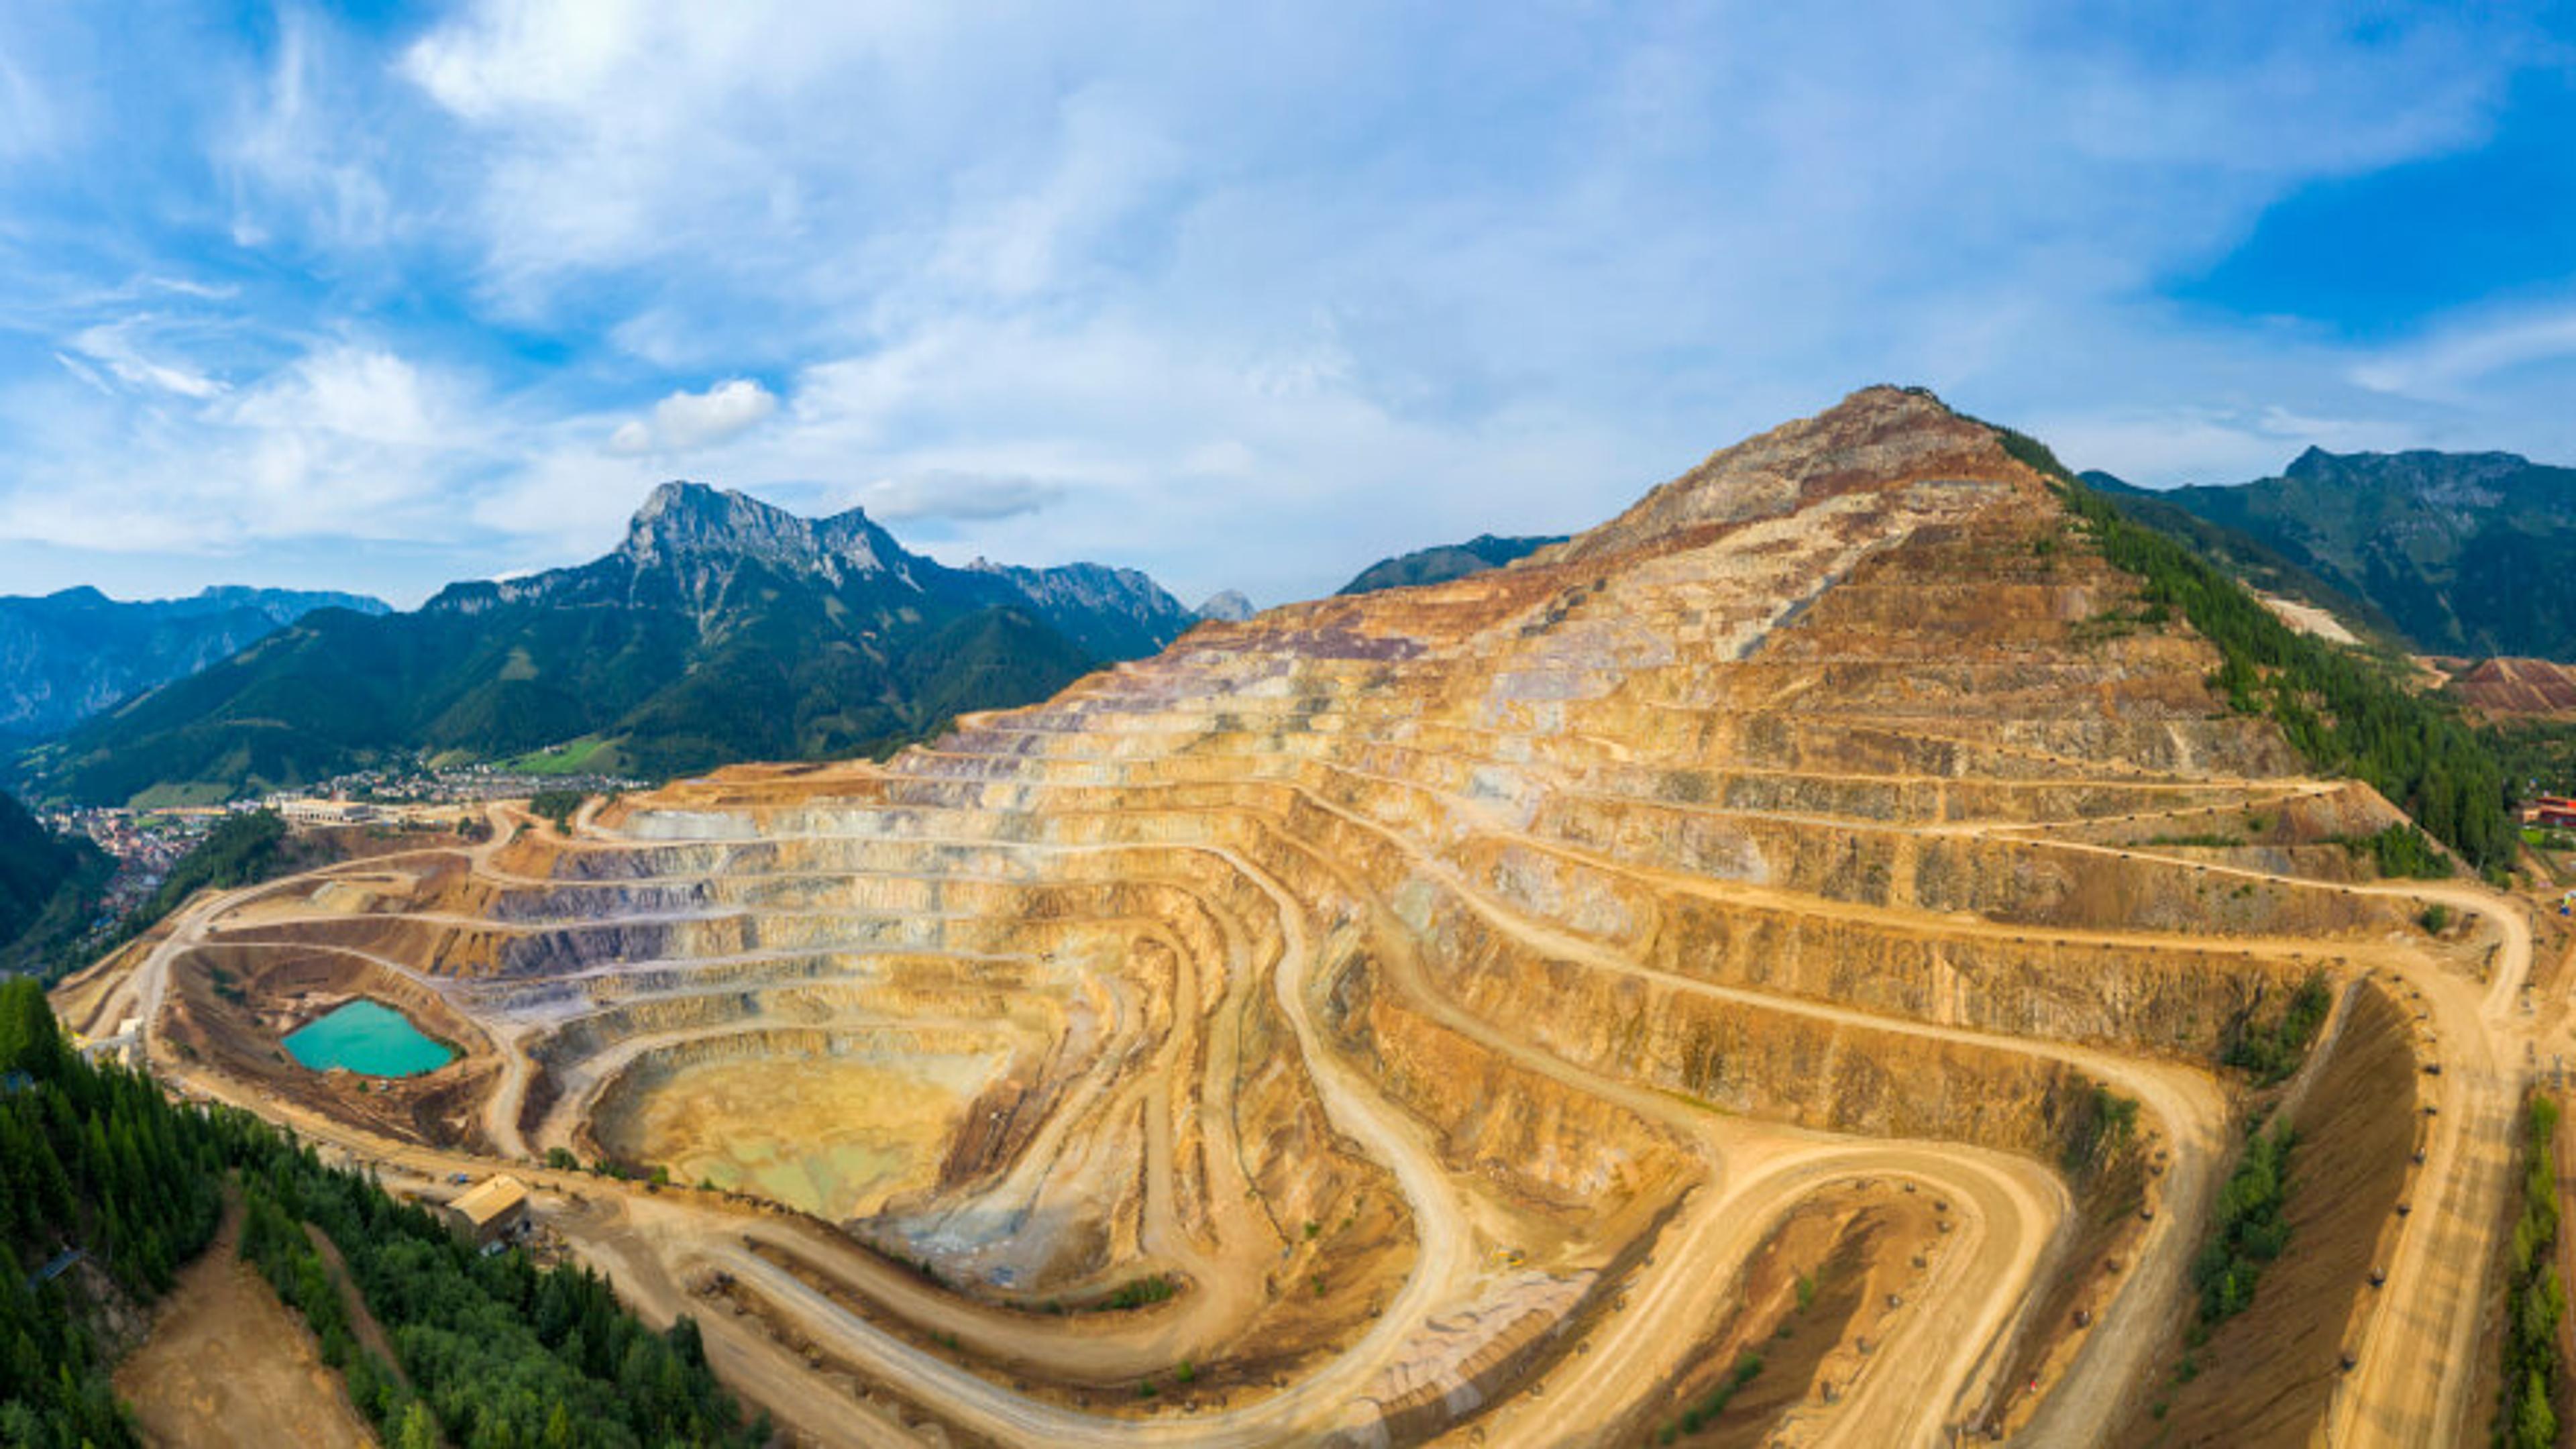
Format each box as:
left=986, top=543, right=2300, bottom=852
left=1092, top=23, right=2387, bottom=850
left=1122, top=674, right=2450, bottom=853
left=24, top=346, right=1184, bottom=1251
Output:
left=62, top=389, right=2561, bottom=1449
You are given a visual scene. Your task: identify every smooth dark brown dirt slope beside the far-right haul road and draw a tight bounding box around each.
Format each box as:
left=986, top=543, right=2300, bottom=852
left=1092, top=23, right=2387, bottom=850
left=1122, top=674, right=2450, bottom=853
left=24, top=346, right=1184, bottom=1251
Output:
left=2117, top=982, right=2422, bottom=1449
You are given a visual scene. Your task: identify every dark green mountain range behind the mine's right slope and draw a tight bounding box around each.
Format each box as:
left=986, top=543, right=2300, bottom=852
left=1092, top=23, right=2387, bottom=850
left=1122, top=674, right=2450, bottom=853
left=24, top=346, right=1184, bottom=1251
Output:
left=2086, top=449, right=2576, bottom=663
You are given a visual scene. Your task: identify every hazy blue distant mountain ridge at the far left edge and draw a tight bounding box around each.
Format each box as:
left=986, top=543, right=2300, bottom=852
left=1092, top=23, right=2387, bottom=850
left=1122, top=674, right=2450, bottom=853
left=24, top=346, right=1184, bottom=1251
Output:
left=0, top=588, right=386, bottom=737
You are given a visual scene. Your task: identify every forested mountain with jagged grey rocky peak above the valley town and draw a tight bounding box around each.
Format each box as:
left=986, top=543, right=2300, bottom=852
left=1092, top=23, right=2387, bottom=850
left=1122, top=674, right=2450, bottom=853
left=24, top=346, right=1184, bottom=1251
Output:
left=21, top=482, right=1195, bottom=804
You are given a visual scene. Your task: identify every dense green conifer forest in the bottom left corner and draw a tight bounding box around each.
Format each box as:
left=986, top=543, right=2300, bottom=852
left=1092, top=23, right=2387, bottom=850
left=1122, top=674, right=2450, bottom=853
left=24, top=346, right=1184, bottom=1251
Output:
left=0, top=979, right=767, bottom=1449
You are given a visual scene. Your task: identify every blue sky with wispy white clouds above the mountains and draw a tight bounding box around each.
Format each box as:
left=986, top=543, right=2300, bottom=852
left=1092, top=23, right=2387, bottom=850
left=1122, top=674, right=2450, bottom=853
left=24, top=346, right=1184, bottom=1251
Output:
left=0, top=0, right=2576, bottom=603
